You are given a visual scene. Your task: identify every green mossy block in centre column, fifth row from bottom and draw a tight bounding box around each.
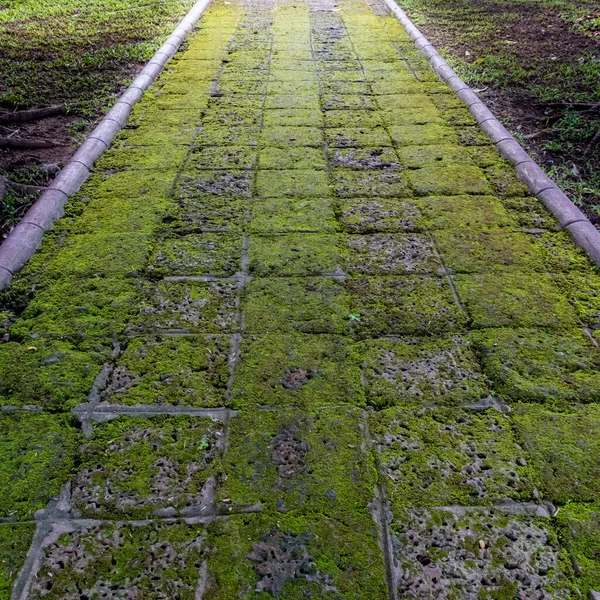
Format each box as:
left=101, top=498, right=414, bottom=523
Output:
left=250, top=233, right=345, bottom=277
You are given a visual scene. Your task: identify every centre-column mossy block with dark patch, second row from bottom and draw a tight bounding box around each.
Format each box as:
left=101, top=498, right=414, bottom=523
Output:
left=217, top=407, right=377, bottom=525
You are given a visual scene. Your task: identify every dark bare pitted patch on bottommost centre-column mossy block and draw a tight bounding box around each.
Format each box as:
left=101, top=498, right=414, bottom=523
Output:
left=246, top=530, right=337, bottom=597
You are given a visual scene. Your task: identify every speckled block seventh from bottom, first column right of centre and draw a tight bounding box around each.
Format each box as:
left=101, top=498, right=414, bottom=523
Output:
left=331, top=169, right=411, bottom=198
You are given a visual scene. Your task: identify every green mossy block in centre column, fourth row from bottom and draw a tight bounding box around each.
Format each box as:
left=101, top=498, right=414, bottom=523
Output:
left=242, top=277, right=350, bottom=334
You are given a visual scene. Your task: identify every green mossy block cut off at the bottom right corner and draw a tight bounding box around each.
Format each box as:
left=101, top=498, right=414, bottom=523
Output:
left=555, top=502, right=600, bottom=594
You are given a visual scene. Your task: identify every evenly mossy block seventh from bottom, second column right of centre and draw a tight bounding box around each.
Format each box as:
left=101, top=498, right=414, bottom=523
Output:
left=407, top=164, right=492, bottom=196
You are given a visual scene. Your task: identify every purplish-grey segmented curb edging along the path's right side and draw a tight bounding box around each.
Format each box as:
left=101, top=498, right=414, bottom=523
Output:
left=385, top=0, right=600, bottom=267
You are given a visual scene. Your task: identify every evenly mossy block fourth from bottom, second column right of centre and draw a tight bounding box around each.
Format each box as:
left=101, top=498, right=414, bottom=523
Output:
left=454, top=270, right=577, bottom=329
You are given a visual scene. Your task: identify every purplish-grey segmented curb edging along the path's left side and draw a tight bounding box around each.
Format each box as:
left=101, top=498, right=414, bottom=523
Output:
left=0, top=0, right=211, bottom=290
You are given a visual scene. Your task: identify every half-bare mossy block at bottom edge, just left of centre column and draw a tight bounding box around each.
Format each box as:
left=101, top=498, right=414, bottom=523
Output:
left=29, top=520, right=206, bottom=600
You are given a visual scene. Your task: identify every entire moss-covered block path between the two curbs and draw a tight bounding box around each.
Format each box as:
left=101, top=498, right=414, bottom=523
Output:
left=0, top=0, right=600, bottom=600
